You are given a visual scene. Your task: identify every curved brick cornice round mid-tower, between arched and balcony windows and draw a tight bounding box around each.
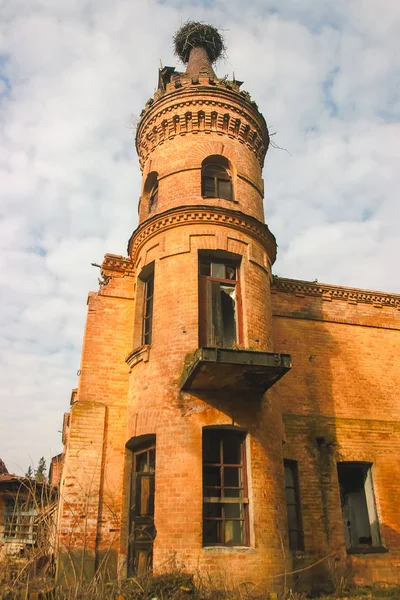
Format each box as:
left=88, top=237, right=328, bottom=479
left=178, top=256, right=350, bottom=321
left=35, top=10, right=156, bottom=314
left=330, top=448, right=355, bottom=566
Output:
left=128, top=206, right=276, bottom=263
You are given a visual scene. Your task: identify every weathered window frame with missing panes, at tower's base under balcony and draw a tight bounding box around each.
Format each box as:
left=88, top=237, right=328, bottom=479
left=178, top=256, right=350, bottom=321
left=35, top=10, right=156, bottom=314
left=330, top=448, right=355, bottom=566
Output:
left=203, top=427, right=250, bottom=547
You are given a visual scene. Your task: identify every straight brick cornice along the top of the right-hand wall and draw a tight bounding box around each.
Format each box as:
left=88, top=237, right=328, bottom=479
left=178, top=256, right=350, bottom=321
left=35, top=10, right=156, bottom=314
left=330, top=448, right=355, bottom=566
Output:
left=271, top=276, right=400, bottom=310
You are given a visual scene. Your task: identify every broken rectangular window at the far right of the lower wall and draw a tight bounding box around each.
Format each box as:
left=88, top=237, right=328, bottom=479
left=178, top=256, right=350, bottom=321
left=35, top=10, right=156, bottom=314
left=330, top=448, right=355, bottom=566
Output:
left=337, top=461, right=385, bottom=553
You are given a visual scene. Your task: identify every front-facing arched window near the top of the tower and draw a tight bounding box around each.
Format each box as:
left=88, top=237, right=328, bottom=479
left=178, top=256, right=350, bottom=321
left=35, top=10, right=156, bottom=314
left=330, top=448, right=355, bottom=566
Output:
left=201, top=155, right=233, bottom=200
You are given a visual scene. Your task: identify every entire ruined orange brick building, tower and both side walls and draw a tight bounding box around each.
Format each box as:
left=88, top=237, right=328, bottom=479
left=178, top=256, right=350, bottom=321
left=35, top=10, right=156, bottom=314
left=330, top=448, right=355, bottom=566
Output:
left=58, top=22, right=400, bottom=588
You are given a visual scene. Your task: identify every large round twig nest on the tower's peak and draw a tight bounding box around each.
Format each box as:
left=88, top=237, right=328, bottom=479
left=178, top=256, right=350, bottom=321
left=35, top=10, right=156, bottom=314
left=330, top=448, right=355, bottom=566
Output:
left=173, top=21, right=226, bottom=64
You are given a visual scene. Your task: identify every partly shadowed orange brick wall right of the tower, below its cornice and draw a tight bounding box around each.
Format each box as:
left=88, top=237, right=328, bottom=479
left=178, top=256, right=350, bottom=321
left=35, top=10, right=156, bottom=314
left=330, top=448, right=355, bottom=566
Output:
left=270, top=279, right=400, bottom=584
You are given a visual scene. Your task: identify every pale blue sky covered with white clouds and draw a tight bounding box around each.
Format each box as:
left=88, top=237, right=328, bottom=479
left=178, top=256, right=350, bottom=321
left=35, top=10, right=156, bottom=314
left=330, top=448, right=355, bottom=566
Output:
left=0, top=0, right=400, bottom=473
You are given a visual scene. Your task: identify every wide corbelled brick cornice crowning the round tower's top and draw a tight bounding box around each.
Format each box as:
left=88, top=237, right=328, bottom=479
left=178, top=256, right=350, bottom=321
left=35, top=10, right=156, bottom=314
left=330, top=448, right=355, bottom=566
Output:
left=136, top=90, right=269, bottom=169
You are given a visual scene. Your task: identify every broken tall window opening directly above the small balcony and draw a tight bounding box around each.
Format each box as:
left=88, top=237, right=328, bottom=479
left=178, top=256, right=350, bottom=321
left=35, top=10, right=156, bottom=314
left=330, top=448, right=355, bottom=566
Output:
left=199, top=255, right=243, bottom=348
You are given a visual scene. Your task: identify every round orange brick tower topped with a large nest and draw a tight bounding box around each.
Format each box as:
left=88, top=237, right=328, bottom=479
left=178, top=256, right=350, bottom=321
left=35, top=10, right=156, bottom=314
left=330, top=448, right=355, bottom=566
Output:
left=127, top=23, right=290, bottom=592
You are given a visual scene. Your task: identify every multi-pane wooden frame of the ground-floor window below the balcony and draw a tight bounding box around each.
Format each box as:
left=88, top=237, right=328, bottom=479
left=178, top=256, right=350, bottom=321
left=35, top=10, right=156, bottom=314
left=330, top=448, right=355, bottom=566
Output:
left=202, top=427, right=250, bottom=547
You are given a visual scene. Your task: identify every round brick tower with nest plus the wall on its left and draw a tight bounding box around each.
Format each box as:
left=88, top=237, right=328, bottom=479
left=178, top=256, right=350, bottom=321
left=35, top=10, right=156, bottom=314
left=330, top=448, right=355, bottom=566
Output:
left=59, top=24, right=291, bottom=583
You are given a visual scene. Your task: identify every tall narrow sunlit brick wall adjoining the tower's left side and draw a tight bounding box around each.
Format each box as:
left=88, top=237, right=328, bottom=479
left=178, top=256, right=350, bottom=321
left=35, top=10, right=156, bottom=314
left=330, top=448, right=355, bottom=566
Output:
left=59, top=256, right=133, bottom=581
